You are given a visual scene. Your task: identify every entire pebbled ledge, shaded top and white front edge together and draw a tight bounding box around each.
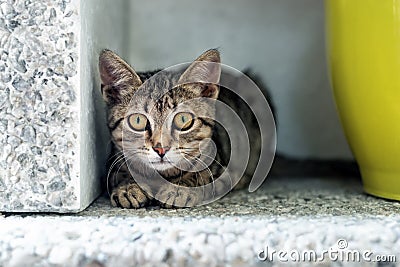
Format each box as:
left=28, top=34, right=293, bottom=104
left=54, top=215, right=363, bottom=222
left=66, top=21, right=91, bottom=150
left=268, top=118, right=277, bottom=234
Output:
left=0, top=176, right=400, bottom=267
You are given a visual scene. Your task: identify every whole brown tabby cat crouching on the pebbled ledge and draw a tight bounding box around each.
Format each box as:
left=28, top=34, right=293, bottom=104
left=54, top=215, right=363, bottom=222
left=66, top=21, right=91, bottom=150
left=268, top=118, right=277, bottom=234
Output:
left=99, top=49, right=260, bottom=208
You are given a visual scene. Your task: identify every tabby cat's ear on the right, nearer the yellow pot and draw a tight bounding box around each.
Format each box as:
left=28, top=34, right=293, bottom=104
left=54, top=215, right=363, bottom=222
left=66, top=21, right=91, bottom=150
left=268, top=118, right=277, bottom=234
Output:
left=178, top=49, right=221, bottom=99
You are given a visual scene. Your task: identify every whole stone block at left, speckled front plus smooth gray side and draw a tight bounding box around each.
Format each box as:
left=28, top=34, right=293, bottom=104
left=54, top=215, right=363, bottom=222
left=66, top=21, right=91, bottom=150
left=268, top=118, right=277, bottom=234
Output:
left=0, top=0, right=127, bottom=212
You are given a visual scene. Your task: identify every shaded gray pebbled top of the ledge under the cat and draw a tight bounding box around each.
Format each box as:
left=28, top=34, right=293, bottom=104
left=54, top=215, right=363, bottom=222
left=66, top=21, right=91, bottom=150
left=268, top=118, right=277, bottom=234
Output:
left=78, top=177, right=400, bottom=218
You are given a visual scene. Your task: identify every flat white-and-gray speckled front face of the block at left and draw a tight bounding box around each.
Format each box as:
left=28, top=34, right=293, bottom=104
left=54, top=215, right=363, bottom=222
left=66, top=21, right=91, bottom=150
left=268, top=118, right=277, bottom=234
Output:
left=0, top=0, right=80, bottom=211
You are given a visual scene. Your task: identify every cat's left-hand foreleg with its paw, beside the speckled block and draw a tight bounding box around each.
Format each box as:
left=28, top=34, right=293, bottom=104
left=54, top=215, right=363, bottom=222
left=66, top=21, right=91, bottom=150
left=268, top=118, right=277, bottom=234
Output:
left=110, top=170, right=151, bottom=209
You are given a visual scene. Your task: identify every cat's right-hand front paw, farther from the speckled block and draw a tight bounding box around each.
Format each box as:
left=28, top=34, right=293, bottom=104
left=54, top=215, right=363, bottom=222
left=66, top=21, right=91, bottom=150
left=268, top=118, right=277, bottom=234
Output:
left=156, top=186, right=202, bottom=209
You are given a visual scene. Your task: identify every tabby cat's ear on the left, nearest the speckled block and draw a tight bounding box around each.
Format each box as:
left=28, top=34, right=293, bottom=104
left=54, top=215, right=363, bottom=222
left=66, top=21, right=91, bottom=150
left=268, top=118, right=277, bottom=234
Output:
left=99, top=50, right=142, bottom=103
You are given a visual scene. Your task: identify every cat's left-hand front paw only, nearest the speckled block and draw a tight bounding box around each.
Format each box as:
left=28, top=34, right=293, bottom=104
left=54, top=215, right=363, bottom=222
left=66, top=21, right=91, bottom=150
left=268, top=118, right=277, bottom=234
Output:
left=111, top=183, right=150, bottom=209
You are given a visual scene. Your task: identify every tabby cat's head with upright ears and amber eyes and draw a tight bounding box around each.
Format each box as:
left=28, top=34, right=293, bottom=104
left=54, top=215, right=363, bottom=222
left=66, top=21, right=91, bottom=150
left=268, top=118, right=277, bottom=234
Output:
left=99, top=49, right=221, bottom=171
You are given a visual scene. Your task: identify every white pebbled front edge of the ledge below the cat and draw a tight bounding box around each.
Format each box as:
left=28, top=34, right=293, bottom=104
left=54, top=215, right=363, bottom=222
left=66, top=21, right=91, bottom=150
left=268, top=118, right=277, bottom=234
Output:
left=0, top=216, right=400, bottom=267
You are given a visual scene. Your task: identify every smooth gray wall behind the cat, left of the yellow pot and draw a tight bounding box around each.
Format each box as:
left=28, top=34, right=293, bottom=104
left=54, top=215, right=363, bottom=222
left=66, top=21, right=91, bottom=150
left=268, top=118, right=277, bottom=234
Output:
left=128, top=0, right=351, bottom=158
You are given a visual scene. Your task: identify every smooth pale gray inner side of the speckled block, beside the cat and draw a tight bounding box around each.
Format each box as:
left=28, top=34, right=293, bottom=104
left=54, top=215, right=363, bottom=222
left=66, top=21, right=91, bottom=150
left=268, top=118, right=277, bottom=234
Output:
left=79, top=0, right=129, bottom=205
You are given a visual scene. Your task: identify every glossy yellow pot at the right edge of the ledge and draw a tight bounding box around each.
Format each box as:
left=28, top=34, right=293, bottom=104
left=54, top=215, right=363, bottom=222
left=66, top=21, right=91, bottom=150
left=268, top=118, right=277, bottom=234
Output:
left=325, top=0, right=400, bottom=200
